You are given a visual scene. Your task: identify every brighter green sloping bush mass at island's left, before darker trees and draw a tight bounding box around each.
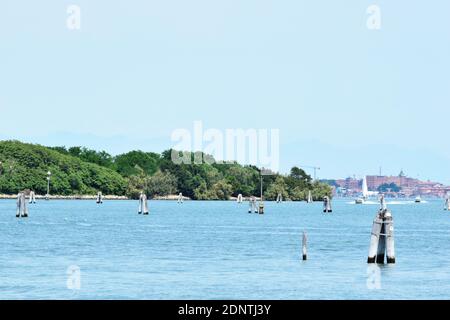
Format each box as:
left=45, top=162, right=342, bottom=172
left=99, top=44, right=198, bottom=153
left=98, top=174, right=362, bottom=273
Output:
left=0, top=141, right=127, bottom=195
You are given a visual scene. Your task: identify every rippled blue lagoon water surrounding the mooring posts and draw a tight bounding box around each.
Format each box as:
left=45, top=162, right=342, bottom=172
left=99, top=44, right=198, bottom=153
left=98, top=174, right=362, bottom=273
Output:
left=0, top=200, right=450, bottom=299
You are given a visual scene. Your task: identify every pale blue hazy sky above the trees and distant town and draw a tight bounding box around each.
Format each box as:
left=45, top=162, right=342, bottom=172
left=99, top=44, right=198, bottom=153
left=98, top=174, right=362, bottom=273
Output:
left=0, top=0, right=450, bottom=184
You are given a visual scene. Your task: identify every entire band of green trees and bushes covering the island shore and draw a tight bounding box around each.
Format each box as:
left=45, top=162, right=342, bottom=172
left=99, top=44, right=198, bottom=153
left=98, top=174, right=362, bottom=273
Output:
left=0, top=141, right=331, bottom=200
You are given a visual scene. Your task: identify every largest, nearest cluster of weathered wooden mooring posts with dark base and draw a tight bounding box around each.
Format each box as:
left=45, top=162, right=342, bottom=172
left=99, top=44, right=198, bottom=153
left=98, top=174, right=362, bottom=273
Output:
left=367, top=196, right=395, bottom=264
